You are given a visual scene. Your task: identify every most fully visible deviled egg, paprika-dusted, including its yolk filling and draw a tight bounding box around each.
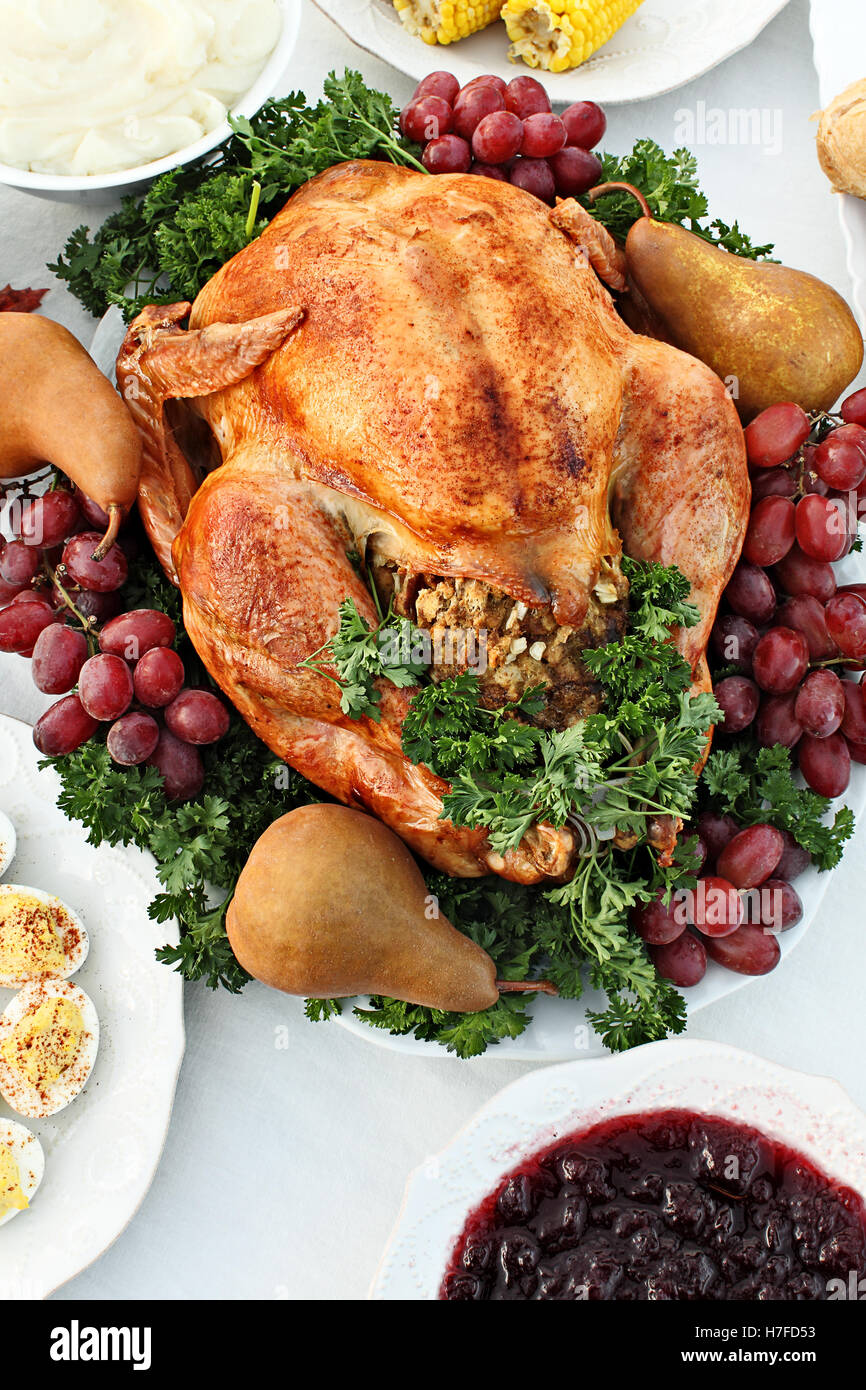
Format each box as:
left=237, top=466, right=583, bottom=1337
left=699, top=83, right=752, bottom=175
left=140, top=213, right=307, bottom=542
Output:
left=0, top=980, right=99, bottom=1116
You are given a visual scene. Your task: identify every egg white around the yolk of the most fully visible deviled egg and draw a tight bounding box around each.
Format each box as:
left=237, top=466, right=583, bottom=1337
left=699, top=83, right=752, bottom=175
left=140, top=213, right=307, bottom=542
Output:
left=0, top=980, right=99, bottom=1118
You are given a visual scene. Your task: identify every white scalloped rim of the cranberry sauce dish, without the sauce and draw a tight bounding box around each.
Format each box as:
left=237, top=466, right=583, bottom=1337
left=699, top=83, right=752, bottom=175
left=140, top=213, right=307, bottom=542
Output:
left=370, top=1040, right=866, bottom=1300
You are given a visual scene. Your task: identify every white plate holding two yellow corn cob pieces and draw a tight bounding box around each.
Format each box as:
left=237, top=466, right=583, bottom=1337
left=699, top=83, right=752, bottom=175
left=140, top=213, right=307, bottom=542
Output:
left=316, top=0, right=787, bottom=104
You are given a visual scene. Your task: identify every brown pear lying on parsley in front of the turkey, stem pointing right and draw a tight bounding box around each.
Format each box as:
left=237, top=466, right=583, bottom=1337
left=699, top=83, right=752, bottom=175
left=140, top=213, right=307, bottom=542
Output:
left=227, top=805, right=500, bottom=1013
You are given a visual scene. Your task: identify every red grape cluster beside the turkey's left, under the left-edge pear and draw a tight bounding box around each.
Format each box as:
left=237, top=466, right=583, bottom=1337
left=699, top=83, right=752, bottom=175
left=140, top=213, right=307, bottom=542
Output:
left=0, top=487, right=229, bottom=801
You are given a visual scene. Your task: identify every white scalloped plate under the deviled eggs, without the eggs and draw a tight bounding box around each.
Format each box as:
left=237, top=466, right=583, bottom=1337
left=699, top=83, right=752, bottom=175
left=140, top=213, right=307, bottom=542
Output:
left=0, top=714, right=183, bottom=1300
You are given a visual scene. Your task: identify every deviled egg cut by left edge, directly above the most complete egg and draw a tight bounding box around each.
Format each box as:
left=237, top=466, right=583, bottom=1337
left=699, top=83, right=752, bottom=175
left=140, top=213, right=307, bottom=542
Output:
left=0, top=883, right=89, bottom=990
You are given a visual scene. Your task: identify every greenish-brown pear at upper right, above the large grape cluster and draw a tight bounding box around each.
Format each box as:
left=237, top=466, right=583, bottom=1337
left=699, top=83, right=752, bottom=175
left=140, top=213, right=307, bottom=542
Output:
left=626, top=217, right=863, bottom=420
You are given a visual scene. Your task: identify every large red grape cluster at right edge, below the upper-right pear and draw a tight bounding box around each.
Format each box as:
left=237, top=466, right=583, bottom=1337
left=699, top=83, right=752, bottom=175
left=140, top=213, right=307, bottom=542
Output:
left=710, top=391, right=866, bottom=796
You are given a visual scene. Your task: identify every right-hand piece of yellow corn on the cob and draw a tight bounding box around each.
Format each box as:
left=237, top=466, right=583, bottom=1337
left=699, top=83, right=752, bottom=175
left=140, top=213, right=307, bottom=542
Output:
left=500, top=0, right=642, bottom=72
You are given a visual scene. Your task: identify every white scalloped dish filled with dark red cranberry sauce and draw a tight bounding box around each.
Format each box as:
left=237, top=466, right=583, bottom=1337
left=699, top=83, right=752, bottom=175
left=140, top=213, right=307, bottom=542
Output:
left=370, top=1038, right=866, bottom=1302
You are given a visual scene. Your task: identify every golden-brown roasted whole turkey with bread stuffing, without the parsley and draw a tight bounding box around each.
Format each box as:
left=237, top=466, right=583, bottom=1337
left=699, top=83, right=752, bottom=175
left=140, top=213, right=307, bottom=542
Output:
left=118, top=163, right=749, bottom=883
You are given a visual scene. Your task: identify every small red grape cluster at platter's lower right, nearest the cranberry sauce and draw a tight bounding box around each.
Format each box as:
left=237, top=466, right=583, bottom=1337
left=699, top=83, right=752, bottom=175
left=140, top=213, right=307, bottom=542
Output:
left=630, top=810, right=812, bottom=988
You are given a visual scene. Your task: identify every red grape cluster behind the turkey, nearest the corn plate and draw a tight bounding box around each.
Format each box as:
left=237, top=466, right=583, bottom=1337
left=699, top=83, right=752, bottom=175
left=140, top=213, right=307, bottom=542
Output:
left=400, top=72, right=607, bottom=203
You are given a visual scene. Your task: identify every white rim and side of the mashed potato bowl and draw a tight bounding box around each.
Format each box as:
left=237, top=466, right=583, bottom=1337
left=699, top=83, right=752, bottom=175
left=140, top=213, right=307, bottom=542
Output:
left=0, top=0, right=300, bottom=204
